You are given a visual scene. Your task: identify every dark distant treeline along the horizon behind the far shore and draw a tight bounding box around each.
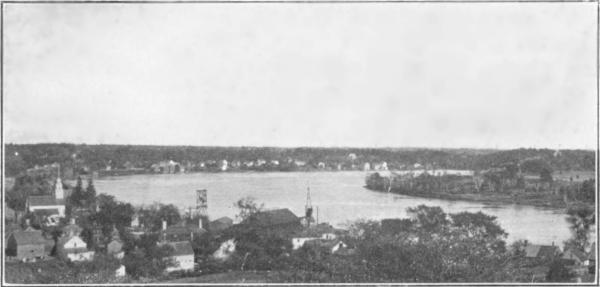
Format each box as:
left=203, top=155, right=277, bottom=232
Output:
left=5, top=143, right=595, bottom=176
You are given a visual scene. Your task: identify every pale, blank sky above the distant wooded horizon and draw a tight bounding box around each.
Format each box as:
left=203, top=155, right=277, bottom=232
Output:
left=2, top=2, right=597, bottom=149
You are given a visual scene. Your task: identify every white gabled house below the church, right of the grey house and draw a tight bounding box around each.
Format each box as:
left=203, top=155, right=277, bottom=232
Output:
left=56, top=220, right=94, bottom=262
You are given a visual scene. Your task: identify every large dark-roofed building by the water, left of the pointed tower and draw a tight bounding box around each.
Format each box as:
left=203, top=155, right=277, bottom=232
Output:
left=242, top=208, right=302, bottom=232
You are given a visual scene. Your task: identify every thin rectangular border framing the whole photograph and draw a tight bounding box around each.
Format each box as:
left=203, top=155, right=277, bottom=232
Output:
left=0, top=0, right=600, bottom=286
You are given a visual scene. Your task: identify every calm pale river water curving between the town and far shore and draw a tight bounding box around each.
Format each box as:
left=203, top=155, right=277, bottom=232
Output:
left=95, top=171, right=570, bottom=246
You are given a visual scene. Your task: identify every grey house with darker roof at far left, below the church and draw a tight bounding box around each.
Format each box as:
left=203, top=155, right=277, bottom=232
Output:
left=6, top=228, right=50, bottom=262
